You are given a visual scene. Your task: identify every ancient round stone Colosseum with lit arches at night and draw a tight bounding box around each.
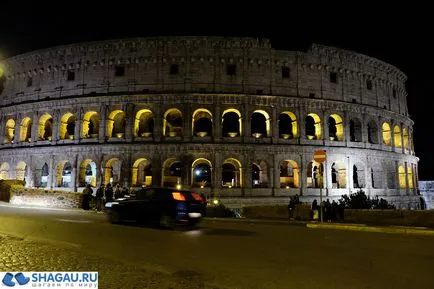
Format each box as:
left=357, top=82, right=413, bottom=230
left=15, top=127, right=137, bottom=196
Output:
left=0, top=37, right=419, bottom=208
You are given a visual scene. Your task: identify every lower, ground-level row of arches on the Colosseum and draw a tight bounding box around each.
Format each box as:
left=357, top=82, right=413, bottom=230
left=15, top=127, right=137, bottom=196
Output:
left=0, top=158, right=415, bottom=189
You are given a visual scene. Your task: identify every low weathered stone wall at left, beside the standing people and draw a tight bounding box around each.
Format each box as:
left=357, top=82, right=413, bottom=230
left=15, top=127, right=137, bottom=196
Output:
left=9, top=187, right=83, bottom=209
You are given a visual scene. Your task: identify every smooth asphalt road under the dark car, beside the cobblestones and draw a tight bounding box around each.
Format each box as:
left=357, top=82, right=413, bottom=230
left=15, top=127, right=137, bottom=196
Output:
left=0, top=202, right=434, bottom=289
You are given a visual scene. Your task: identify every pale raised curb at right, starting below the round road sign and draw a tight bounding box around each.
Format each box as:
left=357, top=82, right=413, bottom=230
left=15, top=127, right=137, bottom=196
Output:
left=306, top=223, right=434, bottom=236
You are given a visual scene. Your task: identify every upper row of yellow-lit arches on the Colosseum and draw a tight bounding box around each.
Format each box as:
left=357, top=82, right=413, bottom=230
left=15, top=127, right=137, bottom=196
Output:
left=4, top=108, right=411, bottom=149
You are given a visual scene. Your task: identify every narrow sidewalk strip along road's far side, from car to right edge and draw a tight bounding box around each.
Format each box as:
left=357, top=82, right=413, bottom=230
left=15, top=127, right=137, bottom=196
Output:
left=204, top=218, right=434, bottom=236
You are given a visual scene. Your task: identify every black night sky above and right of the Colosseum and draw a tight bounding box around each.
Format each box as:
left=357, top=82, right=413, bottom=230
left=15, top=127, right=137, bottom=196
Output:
left=0, top=0, right=434, bottom=180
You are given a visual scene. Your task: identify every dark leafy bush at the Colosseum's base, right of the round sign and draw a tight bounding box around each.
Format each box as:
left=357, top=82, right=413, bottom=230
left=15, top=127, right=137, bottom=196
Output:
left=339, top=189, right=395, bottom=210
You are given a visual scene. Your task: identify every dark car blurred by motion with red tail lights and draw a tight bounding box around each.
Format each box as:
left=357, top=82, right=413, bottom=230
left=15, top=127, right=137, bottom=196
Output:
left=105, top=188, right=206, bottom=228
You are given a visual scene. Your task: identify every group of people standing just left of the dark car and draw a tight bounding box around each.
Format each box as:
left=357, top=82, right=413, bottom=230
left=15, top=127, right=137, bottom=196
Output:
left=82, top=184, right=130, bottom=212
